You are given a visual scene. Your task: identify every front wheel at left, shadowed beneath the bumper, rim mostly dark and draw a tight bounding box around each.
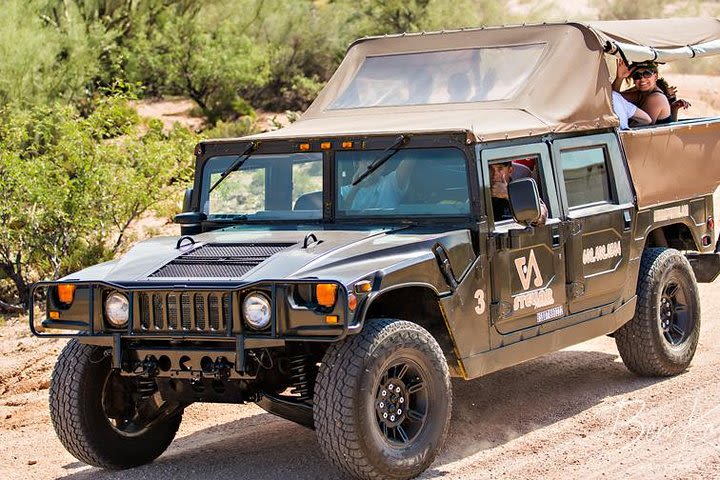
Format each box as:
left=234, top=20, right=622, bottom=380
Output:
left=50, top=339, right=182, bottom=470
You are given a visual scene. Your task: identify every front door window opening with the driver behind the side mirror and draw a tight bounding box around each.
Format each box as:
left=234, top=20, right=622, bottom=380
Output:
left=489, top=154, right=547, bottom=222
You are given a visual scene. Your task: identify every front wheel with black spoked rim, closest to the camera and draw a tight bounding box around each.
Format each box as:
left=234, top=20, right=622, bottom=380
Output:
left=314, top=319, right=452, bottom=479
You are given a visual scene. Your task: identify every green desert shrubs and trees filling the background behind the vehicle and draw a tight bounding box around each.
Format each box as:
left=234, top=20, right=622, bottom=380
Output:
left=0, top=0, right=720, bottom=311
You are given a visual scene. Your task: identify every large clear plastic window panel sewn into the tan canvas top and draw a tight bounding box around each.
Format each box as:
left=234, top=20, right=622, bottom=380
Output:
left=329, top=44, right=545, bottom=110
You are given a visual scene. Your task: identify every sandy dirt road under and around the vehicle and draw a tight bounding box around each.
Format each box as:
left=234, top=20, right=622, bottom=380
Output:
left=0, top=281, right=720, bottom=480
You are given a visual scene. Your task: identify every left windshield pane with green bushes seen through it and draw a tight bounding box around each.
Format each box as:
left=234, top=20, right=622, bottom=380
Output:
left=202, top=153, right=323, bottom=220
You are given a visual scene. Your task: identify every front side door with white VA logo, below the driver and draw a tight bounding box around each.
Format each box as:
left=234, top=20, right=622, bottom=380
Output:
left=478, top=143, right=567, bottom=336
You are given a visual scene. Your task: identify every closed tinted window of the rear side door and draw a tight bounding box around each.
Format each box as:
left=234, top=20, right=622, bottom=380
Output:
left=560, top=146, right=614, bottom=208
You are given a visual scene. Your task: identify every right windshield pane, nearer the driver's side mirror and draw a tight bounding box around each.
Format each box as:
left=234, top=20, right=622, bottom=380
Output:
left=335, top=148, right=470, bottom=218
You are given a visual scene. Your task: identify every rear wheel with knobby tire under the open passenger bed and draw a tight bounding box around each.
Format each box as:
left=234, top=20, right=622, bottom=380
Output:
left=615, top=248, right=700, bottom=377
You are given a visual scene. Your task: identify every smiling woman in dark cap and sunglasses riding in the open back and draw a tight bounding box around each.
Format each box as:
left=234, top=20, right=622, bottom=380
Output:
left=613, top=59, right=690, bottom=125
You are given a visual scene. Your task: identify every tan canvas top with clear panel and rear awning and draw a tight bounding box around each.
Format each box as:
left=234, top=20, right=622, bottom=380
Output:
left=246, top=18, right=720, bottom=141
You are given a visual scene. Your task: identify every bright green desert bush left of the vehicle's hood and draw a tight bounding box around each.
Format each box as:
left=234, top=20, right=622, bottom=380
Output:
left=0, top=96, right=197, bottom=304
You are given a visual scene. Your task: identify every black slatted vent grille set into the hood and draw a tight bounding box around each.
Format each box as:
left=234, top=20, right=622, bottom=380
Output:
left=150, top=243, right=295, bottom=278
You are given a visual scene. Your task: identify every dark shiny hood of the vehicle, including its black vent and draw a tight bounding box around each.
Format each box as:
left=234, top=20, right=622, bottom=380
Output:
left=64, top=228, right=476, bottom=285
